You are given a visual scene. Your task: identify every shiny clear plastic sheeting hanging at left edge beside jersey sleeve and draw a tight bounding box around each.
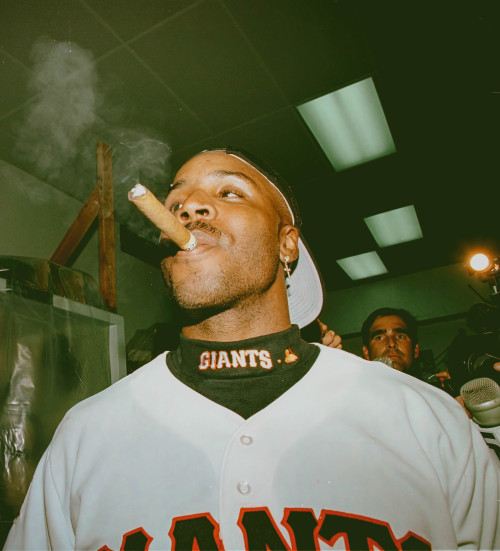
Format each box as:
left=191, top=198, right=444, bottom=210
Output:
left=0, top=257, right=120, bottom=544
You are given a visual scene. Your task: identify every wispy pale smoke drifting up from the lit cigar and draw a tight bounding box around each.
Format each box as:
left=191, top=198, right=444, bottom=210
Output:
left=16, top=37, right=171, bottom=242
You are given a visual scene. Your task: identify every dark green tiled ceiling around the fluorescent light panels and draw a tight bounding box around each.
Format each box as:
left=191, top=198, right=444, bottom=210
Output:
left=0, top=0, right=500, bottom=291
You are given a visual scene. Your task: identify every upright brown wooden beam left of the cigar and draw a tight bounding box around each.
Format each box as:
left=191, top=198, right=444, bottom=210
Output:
left=97, top=142, right=116, bottom=312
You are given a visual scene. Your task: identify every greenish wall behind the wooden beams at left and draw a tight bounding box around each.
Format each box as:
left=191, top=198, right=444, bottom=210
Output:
left=0, top=157, right=172, bottom=341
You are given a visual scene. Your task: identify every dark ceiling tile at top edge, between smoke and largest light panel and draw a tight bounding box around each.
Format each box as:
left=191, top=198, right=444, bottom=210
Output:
left=131, top=1, right=284, bottom=132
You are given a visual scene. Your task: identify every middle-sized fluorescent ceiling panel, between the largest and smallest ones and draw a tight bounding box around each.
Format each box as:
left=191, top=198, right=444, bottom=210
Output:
left=365, top=205, right=423, bottom=247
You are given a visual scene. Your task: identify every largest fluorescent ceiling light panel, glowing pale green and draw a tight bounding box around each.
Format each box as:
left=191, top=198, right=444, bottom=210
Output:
left=297, top=77, right=396, bottom=171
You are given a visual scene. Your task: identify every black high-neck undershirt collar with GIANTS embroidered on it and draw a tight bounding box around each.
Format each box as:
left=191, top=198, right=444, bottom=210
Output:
left=167, top=325, right=319, bottom=419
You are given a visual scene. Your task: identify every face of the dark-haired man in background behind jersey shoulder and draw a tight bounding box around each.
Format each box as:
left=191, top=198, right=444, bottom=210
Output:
left=363, top=316, right=418, bottom=371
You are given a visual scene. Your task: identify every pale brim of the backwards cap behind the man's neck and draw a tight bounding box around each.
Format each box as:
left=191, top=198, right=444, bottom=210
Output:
left=287, top=238, right=323, bottom=328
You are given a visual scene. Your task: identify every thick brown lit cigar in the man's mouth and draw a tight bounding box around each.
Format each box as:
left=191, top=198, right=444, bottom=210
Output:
left=128, top=184, right=198, bottom=251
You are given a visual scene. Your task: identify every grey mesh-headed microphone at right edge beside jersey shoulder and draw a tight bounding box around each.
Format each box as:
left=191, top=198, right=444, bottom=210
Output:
left=460, top=377, right=500, bottom=427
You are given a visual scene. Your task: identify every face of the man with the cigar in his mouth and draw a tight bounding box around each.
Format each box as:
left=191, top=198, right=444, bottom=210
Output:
left=162, top=152, right=292, bottom=310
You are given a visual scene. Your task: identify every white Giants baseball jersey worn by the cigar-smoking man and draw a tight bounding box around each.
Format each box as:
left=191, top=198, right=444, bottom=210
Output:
left=5, top=346, right=500, bottom=551
